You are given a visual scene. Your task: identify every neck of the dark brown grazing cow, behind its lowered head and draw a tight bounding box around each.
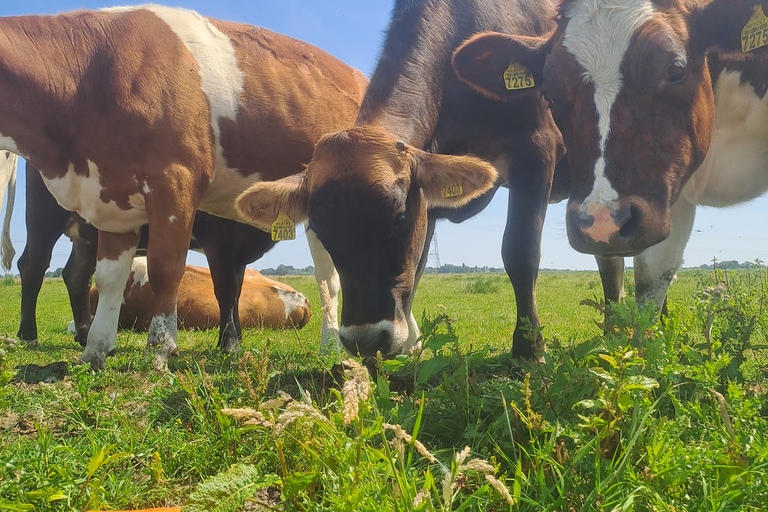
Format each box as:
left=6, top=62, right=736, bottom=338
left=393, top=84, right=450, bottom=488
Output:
left=356, top=0, right=462, bottom=148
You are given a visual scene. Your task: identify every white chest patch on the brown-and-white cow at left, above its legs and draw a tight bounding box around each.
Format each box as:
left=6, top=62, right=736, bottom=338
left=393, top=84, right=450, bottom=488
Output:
left=43, top=160, right=147, bottom=233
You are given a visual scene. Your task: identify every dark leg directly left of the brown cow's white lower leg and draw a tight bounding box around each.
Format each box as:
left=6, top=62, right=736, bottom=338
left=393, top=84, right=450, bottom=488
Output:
left=62, top=239, right=96, bottom=347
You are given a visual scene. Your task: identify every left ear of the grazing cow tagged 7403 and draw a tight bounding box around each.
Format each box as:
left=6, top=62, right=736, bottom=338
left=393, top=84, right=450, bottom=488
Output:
left=235, top=173, right=309, bottom=231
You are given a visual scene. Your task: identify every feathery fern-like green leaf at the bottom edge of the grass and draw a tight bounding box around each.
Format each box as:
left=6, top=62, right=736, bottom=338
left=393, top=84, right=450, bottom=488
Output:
left=181, top=464, right=280, bottom=512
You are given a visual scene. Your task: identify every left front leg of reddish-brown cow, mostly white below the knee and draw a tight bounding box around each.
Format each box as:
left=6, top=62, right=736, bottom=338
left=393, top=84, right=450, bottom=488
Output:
left=80, top=230, right=139, bottom=370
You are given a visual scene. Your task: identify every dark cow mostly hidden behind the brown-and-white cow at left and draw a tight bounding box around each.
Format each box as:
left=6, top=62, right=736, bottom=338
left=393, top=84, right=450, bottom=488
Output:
left=18, top=164, right=275, bottom=352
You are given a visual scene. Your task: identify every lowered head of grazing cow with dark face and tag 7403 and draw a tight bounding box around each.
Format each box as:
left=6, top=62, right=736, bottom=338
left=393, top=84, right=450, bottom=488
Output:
left=237, top=126, right=497, bottom=356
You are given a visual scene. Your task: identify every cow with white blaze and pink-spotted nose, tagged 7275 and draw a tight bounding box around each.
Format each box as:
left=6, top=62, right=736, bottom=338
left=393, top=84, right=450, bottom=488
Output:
left=457, top=0, right=768, bottom=306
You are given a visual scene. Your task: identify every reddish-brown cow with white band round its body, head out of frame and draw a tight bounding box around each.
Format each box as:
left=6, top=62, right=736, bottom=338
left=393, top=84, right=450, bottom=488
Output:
left=0, top=5, right=367, bottom=368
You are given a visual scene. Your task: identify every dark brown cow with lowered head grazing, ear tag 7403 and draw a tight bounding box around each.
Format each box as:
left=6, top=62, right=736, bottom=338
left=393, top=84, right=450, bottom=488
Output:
left=238, top=0, right=567, bottom=358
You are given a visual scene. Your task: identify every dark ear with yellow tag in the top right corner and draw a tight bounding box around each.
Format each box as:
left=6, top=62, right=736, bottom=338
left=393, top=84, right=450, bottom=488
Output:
left=688, top=0, right=768, bottom=54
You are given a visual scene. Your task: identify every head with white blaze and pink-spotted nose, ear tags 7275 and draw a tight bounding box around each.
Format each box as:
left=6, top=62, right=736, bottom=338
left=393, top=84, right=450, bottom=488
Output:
left=454, top=0, right=768, bottom=256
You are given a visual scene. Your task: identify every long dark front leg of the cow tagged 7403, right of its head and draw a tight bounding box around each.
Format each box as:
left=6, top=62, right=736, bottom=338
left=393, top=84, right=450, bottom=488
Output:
left=501, top=155, right=554, bottom=362
